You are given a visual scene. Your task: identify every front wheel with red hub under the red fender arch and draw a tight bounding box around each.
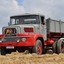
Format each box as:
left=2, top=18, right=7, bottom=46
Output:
left=32, top=40, right=43, bottom=55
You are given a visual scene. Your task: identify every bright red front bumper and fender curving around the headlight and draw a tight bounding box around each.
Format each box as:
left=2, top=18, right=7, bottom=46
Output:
left=0, top=34, right=43, bottom=46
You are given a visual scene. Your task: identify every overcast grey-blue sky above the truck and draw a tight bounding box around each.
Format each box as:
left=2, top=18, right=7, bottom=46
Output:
left=0, top=0, right=64, bottom=33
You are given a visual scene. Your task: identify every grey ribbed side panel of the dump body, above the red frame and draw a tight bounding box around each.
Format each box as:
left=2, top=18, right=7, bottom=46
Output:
left=46, top=19, right=64, bottom=33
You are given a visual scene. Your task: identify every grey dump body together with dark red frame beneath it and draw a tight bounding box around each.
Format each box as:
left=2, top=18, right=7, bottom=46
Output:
left=46, top=18, right=64, bottom=39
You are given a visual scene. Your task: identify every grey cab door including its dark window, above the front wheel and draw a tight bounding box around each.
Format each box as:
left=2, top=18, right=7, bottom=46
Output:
left=40, top=16, right=47, bottom=40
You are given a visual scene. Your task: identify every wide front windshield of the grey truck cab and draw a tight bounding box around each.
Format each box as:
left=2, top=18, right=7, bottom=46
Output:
left=10, top=15, right=40, bottom=25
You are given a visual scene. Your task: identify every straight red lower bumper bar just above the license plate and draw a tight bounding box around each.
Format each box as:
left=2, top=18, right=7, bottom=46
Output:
left=0, top=42, right=34, bottom=47
